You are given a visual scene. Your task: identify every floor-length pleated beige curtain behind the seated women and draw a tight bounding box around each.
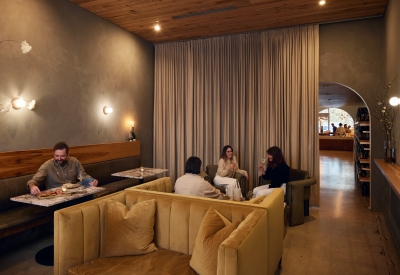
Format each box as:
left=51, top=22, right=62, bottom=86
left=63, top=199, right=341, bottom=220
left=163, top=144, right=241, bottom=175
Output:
left=154, top=25, right=319, bottom=205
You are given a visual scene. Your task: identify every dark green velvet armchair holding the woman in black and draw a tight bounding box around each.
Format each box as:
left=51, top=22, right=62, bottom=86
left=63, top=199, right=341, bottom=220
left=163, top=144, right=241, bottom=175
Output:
left=254, top=169, right=317, bottom=226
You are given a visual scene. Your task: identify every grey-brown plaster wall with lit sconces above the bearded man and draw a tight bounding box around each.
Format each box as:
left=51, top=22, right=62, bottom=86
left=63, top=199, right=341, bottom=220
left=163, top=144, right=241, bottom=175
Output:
left=0, top=0, right=154, bottom=166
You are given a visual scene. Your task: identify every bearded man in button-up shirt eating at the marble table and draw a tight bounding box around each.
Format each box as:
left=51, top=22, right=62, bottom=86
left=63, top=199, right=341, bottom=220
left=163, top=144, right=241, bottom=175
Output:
left=27, top=141, right=98, bottom=195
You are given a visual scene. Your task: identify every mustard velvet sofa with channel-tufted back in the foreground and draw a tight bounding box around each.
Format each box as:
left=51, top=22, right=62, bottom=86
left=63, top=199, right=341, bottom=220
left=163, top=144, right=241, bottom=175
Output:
left=54, top=188, right=284, bottom=275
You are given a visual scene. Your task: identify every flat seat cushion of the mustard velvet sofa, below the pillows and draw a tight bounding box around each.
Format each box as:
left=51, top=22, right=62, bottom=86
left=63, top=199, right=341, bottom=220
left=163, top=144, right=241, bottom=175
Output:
left=68, top=248, right=197, bottom=275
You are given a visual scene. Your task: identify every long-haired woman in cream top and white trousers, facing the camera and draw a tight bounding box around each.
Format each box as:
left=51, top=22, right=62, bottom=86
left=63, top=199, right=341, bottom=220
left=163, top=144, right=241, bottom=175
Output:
left=214, top=145, right=249, bottom=195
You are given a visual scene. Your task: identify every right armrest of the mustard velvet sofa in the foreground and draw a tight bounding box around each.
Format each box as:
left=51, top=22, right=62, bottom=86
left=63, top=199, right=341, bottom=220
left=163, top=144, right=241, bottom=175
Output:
left=217, top=210, right=272, bottom=275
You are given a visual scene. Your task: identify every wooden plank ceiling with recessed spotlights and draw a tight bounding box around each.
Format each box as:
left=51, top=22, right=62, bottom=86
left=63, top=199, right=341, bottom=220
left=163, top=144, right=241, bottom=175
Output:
left=70, top=0, right=387, bottom=43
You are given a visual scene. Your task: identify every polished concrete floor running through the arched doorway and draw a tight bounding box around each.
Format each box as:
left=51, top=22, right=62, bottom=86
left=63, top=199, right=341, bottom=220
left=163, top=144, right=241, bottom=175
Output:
left=0, top=151, right=400, bottom=275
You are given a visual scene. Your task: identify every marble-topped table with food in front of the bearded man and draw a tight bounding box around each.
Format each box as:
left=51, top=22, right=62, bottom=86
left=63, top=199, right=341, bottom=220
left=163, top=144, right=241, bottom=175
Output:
left=10, top=186, right=105, bottom=266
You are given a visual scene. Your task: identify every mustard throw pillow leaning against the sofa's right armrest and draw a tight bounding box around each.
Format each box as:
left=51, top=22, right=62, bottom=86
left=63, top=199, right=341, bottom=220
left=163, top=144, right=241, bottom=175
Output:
left=190, top=207, right=240, bottom=275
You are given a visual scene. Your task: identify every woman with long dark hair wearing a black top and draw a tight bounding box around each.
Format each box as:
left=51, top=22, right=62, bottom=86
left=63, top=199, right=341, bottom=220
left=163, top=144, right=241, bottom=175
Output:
left=253, top=146, right=290, bottom=198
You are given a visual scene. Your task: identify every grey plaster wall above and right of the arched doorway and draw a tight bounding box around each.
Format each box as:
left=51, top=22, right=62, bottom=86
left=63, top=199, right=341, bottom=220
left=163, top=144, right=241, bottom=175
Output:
left=319, top=18, right=384, bottom=210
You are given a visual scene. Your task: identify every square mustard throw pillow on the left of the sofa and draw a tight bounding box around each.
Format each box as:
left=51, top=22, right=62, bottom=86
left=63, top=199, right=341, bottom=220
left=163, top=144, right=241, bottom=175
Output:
left=101, top=199, right=157, bottom=257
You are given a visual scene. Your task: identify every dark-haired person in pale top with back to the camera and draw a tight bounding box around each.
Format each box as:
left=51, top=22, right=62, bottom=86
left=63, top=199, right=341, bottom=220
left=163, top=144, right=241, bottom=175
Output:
left=175, top=157, right=226, bottom=199
